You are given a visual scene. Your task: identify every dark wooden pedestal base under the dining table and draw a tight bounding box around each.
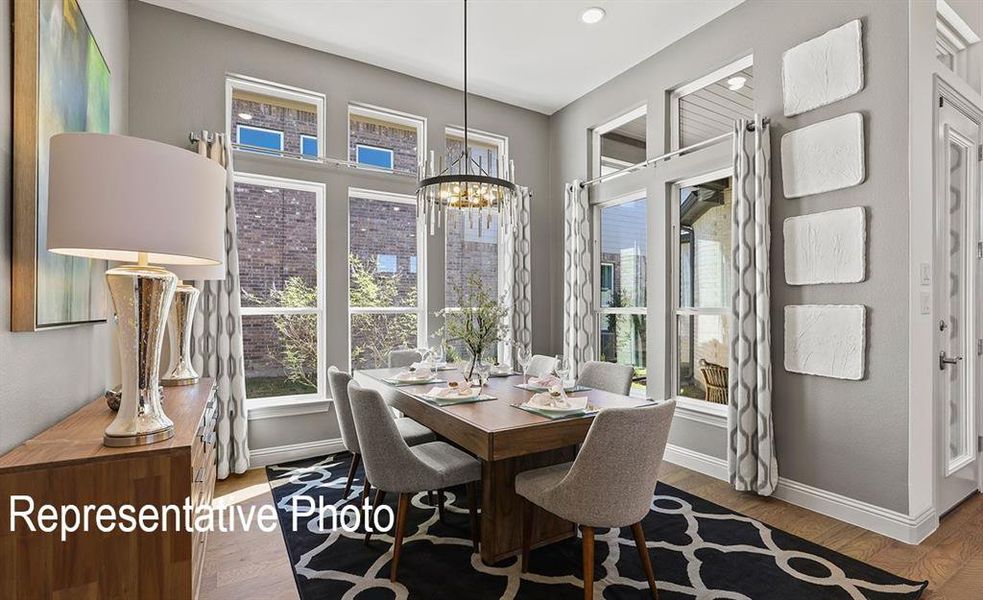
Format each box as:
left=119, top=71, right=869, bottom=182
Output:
left=481, top=446, right=577, bottom=564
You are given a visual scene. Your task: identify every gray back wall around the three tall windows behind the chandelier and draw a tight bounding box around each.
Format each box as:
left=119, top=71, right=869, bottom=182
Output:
left=130, top=2, right=562, bottom=448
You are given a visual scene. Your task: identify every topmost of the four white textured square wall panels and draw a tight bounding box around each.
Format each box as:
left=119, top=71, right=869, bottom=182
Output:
left=782, top=19, right=864, bottom=117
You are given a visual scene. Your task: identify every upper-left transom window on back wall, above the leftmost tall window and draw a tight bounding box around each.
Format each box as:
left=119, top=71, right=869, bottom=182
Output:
left=225, top=75, right=324, bottom=158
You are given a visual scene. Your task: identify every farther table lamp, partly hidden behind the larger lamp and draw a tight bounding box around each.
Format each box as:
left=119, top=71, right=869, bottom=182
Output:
left=160, top=262, right=226, bottom=386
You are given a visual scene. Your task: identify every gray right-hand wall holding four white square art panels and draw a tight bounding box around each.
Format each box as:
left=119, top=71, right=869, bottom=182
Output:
left=550, top=0, right=908, bottom=512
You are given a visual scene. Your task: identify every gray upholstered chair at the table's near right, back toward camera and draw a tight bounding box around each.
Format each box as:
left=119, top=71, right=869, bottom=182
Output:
left=515, top=400, right=676, bottom=600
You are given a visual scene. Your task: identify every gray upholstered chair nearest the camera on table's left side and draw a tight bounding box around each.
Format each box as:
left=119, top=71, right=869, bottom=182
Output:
left=348, top=381, right=481, bottom=581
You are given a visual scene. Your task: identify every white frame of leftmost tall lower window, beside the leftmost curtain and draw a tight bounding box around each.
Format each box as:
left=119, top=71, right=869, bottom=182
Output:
left=234, top=173, right=328, bottom=409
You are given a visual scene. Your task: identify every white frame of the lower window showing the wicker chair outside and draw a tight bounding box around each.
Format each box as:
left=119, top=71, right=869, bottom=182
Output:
left=666, top=167, right=734, bottom=417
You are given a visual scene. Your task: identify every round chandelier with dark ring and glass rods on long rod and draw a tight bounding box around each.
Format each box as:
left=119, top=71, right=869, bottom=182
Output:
left=416, top=0, right=519, bottom=235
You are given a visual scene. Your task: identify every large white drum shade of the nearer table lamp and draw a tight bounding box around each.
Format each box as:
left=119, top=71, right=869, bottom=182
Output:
left=48, top=133, right=226, bottom=264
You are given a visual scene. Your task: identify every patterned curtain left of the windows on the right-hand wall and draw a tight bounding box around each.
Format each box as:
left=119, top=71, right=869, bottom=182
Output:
left=563, top=180, right=596, bottom=378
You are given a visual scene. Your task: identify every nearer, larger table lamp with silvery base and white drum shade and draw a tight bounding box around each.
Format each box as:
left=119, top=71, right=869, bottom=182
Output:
left=48, top=133, right=226, bottom=447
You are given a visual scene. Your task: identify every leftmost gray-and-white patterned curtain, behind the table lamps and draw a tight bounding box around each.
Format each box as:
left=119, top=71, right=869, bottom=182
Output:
left=192, top=131, right=249, bottom=479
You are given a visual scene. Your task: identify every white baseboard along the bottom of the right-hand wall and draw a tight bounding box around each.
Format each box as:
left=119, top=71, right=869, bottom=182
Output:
left=665, top=444, right=939, bottom=544
